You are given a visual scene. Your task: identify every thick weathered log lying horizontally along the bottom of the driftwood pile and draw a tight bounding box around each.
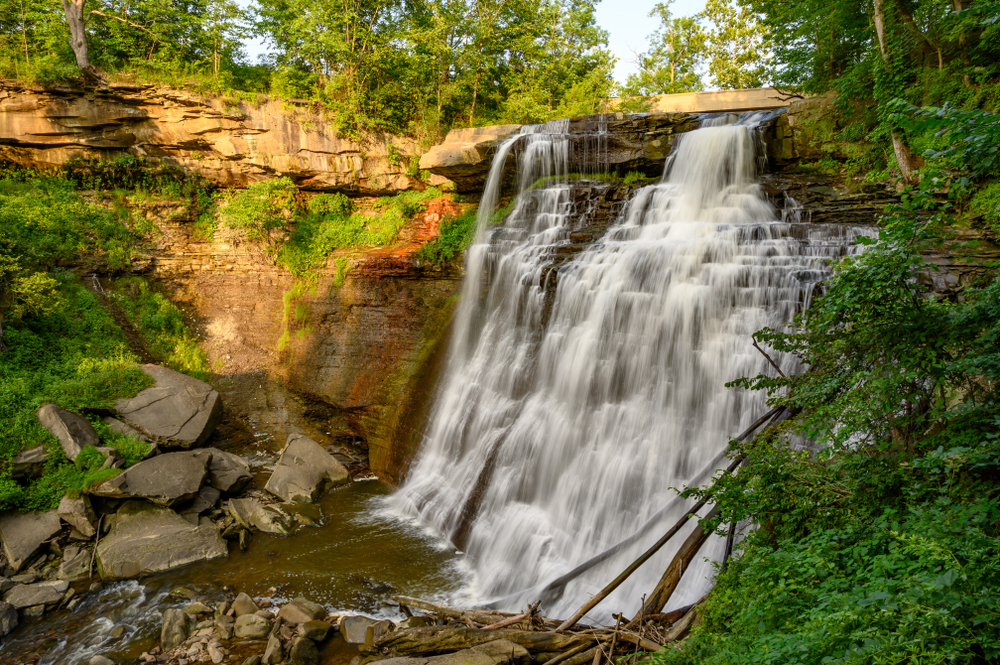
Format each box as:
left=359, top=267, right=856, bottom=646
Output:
left=374, top=626, right=597, bottom=656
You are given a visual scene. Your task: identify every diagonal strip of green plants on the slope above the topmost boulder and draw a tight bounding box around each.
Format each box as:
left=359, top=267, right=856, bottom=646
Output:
left=108, top=277, right=211, bottom=380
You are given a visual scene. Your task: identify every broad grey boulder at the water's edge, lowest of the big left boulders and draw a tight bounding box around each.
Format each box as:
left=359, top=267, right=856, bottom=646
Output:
left=97, top=501, right=228, bottom=580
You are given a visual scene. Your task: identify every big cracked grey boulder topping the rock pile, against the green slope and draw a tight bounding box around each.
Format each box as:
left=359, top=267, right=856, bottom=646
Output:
left=115, top=365, right=222, bottom=448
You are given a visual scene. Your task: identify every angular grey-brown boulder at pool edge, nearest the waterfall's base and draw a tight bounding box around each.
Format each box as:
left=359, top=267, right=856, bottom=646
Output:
left=264, top=434, right=351, bottom=502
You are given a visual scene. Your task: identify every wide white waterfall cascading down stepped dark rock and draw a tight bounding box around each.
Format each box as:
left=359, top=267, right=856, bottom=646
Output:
left=393, top=114, right=864, bottom=621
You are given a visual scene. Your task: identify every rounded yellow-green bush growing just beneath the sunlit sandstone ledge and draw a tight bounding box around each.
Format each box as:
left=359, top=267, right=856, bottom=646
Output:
left=218, top=177, right=296, bottom=244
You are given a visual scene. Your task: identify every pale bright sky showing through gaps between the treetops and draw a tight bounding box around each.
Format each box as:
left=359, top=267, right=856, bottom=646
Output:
left=237, top=0, right=705, bottom=83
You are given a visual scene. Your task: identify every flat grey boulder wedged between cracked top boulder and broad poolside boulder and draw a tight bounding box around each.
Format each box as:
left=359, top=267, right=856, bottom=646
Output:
left=90, top=450, right=212, bottom=507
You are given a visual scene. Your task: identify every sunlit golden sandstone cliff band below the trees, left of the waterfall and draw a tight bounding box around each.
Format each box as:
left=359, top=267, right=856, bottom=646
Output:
left=0, top=81, right=422, bottom=195
